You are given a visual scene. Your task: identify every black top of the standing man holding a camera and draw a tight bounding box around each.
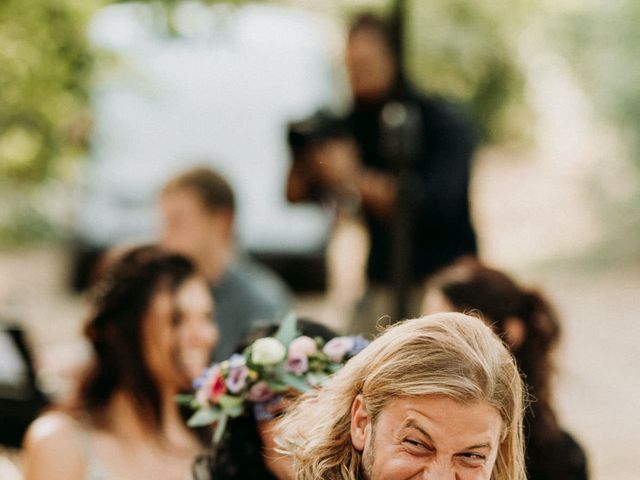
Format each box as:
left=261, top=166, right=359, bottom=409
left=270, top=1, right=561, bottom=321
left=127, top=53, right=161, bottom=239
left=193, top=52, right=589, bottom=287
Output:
left=349, top=84, right=477, bottom=283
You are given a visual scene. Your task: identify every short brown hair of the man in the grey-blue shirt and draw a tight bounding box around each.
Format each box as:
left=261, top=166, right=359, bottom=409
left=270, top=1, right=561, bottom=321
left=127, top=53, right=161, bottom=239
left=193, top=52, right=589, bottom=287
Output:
left=162, top=167, right=236, bottom=213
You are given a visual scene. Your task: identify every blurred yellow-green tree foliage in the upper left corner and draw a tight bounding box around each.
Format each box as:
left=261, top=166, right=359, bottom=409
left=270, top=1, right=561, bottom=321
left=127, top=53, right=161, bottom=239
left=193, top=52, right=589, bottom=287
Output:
left=0, top=0, right=91, bottom=183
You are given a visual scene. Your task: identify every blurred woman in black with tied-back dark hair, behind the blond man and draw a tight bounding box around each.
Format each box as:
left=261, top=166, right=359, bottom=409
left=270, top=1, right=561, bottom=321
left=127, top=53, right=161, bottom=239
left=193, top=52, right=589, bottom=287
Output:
left=422, top=257, right=588, bottom=480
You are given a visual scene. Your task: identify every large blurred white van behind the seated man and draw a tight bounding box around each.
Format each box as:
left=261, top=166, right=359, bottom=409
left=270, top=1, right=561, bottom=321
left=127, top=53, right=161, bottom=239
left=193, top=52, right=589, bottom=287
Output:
left=74, top=2, right=345, bottom=287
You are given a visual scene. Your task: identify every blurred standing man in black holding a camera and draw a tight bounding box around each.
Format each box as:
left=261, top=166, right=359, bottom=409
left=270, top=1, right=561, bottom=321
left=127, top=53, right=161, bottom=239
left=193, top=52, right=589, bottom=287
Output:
left=288, top=15, right=477, bottom=331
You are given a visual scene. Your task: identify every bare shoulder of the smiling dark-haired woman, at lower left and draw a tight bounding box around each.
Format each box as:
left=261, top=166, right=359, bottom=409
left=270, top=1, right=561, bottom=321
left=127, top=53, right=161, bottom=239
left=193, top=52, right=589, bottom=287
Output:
left=24, top=412, right=86, bottom=480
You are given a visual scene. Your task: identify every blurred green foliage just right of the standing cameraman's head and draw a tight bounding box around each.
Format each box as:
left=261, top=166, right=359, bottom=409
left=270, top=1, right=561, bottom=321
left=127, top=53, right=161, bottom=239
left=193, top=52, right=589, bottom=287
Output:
left=407, top=0, right=532, bottom=142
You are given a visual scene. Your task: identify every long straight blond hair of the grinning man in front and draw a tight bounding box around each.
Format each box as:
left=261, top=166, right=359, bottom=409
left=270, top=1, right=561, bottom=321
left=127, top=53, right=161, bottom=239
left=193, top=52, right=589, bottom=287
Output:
left=279, top=313, right=526, bottom=480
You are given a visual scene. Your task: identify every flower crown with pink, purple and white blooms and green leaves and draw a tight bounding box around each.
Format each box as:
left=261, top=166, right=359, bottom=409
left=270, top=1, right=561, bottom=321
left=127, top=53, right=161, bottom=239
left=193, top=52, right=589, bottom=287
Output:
left=178, top=314, right=369, bottom=444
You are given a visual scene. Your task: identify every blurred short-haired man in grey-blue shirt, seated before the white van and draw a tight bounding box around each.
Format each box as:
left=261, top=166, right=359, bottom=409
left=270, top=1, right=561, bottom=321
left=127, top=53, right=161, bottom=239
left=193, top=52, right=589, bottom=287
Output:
left=160, top=168, right=290, bottom=360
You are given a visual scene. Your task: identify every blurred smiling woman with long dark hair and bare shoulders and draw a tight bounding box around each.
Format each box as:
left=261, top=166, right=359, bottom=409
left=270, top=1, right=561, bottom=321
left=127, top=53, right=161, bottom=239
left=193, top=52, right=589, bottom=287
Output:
left=25, top=246, right=217, bottom=480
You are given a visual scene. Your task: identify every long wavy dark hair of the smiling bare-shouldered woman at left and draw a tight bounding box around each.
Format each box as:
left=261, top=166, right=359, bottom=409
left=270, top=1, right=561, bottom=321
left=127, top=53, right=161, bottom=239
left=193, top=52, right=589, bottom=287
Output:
left=73, top=245, right=197, bottom=431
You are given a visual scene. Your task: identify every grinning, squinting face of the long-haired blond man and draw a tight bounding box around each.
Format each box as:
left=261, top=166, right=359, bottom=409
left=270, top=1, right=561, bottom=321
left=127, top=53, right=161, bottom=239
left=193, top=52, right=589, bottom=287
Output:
left=351, top=395, right=502, bottom=480
